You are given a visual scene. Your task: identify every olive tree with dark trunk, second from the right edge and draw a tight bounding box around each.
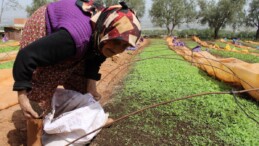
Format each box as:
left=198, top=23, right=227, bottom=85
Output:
left=198, top=0, right=246, bottom=39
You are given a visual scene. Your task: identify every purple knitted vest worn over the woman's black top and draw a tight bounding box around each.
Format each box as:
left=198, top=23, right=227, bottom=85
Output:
left=46, top=0, right=92, bottom=58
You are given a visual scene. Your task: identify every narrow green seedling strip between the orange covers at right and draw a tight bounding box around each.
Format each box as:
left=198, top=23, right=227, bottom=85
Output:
left=184, top=41, right=259, bottom=63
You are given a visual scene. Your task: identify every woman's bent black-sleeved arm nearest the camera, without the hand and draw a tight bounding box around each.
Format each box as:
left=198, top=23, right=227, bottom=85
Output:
left=13, top=29, right=76, bottom=91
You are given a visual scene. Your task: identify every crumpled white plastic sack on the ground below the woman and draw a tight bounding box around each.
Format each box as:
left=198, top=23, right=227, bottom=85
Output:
left=42, top=89, right=108, bottom=146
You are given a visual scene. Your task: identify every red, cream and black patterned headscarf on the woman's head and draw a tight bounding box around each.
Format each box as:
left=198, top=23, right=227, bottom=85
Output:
left=77, top=0, right=141, bottom=50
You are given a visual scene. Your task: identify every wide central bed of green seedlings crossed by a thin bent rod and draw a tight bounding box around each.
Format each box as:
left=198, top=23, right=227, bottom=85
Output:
left=92, top=40, right=259, bottom=146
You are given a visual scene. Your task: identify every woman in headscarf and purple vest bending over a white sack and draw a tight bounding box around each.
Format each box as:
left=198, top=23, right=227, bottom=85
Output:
left=13, top=0, right=141, bottom=118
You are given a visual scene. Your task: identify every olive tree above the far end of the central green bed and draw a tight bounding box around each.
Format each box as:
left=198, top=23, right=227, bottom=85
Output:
left=149, top=0, right=196, bottom=35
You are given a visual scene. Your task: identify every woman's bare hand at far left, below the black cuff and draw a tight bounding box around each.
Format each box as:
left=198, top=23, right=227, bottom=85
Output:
left=18, top=90, right=39, bottom=119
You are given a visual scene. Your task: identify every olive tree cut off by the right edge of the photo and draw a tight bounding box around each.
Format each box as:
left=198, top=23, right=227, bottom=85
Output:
left=246, top=0, right=259, bottom=40
